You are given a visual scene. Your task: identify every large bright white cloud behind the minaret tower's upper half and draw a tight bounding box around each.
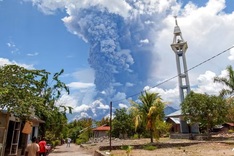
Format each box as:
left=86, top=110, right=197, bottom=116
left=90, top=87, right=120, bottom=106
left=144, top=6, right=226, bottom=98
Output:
left=151, top=0, right=234, bottom=83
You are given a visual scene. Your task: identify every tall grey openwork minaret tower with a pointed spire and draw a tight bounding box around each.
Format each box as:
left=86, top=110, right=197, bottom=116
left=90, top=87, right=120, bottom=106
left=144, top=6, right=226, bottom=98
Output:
left=171, top=16, right=190, bottom=102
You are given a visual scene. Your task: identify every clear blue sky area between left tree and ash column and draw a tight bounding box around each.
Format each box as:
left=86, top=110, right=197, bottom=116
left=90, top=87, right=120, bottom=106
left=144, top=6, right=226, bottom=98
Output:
left=0, top=0, right=89, bottom=77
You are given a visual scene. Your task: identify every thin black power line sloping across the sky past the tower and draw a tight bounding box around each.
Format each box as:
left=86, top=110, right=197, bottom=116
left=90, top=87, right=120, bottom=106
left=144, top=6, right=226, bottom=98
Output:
left=112, top=45, right=234, bottom=103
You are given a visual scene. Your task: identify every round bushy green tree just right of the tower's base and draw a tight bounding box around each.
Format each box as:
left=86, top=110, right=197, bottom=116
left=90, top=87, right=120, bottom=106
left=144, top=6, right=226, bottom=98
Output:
left=181, top=91, right=227, bottom=134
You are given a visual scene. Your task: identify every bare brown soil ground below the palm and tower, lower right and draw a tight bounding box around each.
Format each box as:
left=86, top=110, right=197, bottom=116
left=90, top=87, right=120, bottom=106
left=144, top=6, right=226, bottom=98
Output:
left=82, top=136, right=234, bottom=156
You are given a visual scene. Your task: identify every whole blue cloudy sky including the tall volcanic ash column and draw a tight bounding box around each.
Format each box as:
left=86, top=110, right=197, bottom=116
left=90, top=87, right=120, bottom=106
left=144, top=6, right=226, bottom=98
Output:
left=0, top=0, right=234, bottom=120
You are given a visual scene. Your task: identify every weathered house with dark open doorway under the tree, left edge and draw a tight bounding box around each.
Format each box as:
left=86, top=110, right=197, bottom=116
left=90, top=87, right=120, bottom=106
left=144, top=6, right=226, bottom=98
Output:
left=0, top=110, right=44, bottom=156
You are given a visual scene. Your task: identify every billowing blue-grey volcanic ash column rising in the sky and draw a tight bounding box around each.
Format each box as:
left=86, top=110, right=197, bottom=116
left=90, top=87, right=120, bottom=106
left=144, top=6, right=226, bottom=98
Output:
left=63, top=6, right=172, bottom=100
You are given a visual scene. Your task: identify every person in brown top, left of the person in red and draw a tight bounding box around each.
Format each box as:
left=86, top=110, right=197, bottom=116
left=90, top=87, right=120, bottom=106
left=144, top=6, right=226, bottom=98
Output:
left=25, top=136, right=40, bottom=156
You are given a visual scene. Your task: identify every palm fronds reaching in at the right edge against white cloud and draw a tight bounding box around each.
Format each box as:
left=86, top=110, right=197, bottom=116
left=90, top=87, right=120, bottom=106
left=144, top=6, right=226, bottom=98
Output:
left=214, top=65, right=234, bottom=97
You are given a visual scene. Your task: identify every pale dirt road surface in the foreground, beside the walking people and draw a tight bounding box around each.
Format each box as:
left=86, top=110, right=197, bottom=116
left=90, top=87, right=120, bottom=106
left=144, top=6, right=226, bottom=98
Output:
left=49, top=144, right=92, bottom=156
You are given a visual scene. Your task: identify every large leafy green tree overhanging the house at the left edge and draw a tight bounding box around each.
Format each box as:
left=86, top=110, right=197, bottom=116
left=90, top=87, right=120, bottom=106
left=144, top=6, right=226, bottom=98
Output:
left=0, top=65, right=72, bottom=136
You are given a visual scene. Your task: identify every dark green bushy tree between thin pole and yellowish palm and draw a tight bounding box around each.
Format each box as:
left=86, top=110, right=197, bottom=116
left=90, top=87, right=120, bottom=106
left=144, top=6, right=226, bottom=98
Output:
left=112, top=108, right=134, bottom=137
